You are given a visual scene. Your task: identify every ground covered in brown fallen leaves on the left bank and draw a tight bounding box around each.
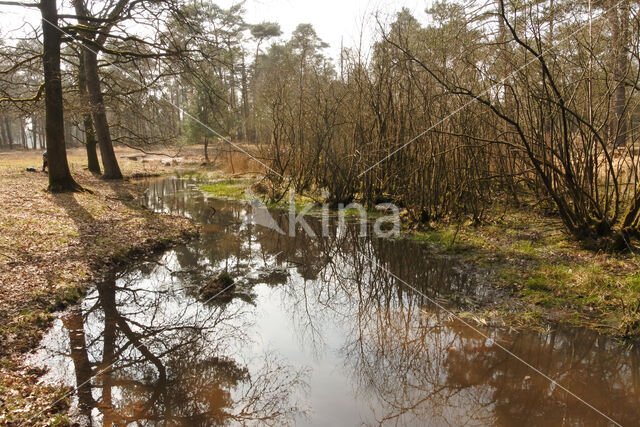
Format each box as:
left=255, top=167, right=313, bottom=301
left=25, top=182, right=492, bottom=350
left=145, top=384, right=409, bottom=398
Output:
left=0, top=149, right=197, bottom=425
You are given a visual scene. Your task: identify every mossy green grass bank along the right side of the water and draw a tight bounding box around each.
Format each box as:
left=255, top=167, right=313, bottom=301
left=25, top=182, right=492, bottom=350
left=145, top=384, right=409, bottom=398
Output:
left=405, top=209, right=640, bottom=337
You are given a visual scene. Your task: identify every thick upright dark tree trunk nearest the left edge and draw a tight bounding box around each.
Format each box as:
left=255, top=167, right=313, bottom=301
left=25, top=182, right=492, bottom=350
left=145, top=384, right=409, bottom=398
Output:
left=40, top=0, right=82, bottom=193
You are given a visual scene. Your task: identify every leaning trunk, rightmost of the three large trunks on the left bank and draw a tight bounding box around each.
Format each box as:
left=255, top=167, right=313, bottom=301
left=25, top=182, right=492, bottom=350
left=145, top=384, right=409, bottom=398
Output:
left=83, top=46, right=122, bottom=179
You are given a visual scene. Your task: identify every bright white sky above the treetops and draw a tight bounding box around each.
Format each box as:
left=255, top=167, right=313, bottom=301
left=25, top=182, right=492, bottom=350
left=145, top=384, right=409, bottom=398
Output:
left=0, top=0, right=432, bottom=63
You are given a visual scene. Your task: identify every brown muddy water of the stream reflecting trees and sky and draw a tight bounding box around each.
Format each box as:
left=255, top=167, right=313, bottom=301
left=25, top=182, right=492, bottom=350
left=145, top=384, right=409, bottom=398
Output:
left=32, top=178, right=640, bottom=426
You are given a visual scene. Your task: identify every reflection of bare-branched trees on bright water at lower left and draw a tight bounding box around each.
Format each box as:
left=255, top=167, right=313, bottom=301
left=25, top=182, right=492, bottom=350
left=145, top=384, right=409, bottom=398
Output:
left=35, top=251, right=306, bottom=425
